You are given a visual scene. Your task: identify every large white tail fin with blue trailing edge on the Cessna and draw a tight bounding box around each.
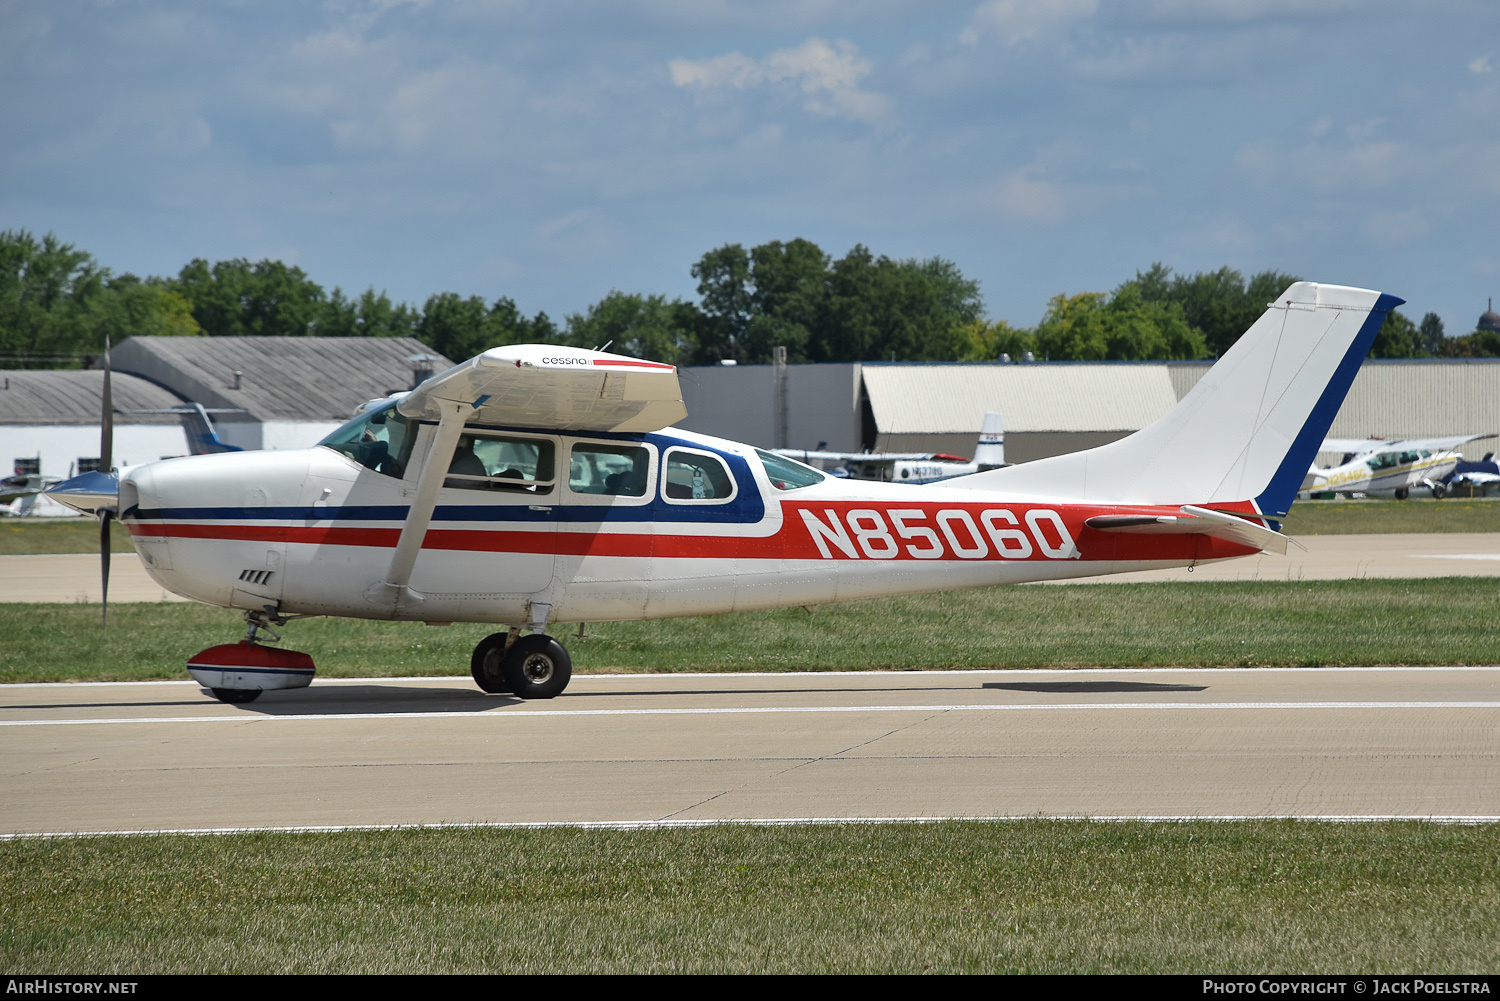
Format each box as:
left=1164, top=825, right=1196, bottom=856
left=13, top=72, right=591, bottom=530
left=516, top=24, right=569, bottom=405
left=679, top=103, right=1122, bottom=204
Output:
left=948, top=282, right=1404, bottom=518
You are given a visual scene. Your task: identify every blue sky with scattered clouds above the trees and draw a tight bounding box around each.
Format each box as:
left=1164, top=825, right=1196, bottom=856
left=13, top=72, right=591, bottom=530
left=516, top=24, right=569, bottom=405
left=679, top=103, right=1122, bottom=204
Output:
left=0, top=0, right=1500, bottom=335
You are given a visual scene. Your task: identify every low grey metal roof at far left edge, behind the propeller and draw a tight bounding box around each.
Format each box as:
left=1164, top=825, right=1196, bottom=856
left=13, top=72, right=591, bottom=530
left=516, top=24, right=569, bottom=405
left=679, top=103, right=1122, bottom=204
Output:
left=0, top=369, right=183, bottom=426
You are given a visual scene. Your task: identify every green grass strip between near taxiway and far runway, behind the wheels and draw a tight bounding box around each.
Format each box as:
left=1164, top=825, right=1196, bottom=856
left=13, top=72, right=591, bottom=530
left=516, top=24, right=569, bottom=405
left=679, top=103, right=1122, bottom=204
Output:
left=0, top=578, right=1500, bottom=681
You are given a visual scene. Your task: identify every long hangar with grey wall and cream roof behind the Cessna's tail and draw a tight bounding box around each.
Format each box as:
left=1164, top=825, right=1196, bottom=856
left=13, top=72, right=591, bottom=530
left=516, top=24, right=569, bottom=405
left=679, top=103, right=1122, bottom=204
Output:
left=681, top=359, right=1500, bottom=462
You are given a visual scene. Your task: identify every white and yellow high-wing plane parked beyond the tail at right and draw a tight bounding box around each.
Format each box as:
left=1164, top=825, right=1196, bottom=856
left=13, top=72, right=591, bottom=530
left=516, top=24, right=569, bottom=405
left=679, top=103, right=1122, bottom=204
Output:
left=1298, top=434, right=1494, bottom=500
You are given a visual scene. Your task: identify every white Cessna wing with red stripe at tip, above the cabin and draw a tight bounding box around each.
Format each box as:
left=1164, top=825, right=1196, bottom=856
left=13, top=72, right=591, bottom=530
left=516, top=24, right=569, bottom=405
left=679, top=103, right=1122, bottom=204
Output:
left=396, top=344, right=687, bottom=431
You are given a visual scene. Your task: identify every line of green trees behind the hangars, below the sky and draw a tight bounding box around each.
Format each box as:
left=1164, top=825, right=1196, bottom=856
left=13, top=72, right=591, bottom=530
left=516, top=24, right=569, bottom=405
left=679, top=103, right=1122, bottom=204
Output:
left=0, top=231, right=1500, bottom=368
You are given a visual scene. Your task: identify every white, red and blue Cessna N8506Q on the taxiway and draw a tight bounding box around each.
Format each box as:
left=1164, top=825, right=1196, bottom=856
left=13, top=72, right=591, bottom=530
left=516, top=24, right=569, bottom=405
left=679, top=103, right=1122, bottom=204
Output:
left=49, top=282, right=1403, bottom=702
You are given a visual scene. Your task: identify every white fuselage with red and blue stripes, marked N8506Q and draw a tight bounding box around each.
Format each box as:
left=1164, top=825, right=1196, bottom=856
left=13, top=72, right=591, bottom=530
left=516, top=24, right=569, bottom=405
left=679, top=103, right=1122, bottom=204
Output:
left=120, top=425, right=1254, bottom=624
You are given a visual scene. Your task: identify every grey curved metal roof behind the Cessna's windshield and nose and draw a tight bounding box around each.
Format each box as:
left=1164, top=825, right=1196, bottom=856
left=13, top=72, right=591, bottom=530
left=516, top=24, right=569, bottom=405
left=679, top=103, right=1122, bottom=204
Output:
left=102, top=338, right=453, bottom=422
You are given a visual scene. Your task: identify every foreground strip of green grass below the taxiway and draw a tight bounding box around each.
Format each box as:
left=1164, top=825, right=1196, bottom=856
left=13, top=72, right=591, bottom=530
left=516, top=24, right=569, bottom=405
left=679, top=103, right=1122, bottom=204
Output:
left=0, top=821, right=1500, bottom=974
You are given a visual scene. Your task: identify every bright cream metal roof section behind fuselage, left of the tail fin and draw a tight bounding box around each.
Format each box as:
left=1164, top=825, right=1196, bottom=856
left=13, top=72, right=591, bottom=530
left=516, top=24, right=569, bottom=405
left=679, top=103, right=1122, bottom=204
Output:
left=863, top=363, right=1178, bottom=434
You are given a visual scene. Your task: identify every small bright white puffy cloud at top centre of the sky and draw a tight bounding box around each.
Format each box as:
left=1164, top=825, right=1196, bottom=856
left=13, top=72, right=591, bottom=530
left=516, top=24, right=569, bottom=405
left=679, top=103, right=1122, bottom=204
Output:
left=668, top=38, right=890, bottom=122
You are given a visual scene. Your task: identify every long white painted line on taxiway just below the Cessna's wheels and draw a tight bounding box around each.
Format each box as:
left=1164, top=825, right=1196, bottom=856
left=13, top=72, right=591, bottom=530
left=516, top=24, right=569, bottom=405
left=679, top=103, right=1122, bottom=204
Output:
left=0, top=702, right=1500, bottom=726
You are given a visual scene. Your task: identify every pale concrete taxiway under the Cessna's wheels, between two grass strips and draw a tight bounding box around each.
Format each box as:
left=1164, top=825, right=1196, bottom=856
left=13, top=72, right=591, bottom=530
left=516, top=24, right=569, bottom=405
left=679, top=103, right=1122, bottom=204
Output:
left=0, top=668, right=1500, bottom=834
